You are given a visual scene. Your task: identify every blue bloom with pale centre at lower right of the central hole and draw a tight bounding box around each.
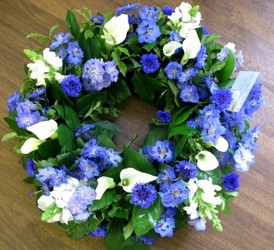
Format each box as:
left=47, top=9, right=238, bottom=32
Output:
left=149, top=141, right=173, bottom=163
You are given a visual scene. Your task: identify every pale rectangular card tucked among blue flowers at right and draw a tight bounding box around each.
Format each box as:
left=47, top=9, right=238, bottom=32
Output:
left=231, top=71, right=260, bottom=112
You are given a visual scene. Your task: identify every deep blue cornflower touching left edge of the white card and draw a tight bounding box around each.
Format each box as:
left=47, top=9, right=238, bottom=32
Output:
left=211, top=89, right=232, bottom=111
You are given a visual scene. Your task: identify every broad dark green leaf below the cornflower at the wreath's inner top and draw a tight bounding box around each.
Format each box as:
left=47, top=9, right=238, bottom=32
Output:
left=131, top=72, right=164, bottom=102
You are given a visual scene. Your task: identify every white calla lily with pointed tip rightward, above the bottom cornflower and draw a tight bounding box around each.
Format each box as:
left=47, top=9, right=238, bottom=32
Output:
left=119, top=168, right=158, bottom=193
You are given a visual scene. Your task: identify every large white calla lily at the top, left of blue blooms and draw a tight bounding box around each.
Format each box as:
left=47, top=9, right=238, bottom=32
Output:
left=102, top=14, right=129, bottom=45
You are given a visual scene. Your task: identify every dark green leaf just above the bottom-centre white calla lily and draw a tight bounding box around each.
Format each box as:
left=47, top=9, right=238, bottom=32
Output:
left=123, top=148, right=157, bottom=176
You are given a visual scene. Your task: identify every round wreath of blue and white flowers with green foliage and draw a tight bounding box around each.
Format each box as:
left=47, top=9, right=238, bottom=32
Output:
left=2, top=2, right=263, bottom=250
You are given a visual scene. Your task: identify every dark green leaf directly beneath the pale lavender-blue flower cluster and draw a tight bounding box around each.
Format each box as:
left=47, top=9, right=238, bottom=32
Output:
left=74, top=92, right=107, bottom=116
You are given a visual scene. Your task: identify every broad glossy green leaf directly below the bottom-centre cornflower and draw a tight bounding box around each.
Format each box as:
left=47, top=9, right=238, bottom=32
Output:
left=132, top=197, right=163, bottom=237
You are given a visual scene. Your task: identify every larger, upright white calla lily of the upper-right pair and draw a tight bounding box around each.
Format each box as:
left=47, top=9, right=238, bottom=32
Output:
left=183, top=30, right=201, bottom=59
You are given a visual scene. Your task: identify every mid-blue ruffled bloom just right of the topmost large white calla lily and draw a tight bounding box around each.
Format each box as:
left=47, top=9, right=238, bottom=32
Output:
left=136, top=19, right=161, bottom=43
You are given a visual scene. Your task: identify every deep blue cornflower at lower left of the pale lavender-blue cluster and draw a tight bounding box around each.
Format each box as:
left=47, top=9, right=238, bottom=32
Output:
left=61, top=75, right=82, bottom=97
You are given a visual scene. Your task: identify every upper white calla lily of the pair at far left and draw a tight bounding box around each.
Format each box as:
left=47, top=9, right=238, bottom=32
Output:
left=27, top=119, right=58, bottom=140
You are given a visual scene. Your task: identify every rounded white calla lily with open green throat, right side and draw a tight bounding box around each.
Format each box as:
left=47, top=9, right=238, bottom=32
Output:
left=195, top=150, right=219, bottom=171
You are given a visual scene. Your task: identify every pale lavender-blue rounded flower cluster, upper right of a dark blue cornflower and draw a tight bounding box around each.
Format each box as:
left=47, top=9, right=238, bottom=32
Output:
left=82, top=59, right=119, bottom=92
